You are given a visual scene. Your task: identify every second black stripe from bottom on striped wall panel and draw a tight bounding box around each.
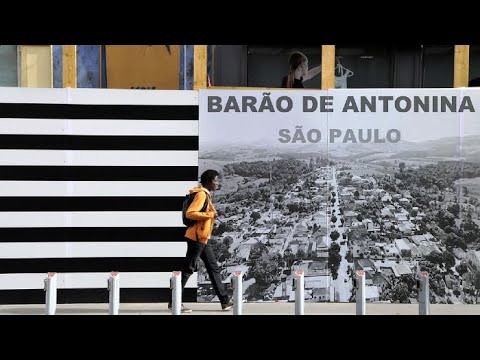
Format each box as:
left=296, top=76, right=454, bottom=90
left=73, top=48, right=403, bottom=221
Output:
left=0, top=257, right=184, bottom=274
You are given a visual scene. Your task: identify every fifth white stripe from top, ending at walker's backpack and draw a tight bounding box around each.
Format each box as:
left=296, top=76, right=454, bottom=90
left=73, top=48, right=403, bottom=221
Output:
left=0, top=211, right=184, bottom=228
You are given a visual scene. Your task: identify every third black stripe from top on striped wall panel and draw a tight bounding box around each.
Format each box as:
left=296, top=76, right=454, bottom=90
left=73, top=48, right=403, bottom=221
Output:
left=0, top=165, right=198, bottom=181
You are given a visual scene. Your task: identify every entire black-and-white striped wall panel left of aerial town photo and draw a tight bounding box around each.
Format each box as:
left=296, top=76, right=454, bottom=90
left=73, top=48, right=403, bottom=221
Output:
left=0, top=88, right=198, bottom=304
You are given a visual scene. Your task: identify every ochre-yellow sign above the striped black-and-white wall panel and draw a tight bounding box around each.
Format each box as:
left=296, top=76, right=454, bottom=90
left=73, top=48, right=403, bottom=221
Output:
left=105, top=45, right=180, bottom=90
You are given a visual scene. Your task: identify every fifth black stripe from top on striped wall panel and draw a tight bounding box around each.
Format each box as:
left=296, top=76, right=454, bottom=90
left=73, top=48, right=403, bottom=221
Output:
left=0, top=226, right=186, bottom=243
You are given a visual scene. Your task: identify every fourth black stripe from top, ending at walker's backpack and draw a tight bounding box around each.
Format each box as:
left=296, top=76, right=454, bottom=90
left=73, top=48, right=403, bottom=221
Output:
left=0, top=196, right=185, bottom=211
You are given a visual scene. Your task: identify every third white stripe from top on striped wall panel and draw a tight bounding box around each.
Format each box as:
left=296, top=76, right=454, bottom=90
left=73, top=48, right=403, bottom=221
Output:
left=0, top=150, right=198, bottom=166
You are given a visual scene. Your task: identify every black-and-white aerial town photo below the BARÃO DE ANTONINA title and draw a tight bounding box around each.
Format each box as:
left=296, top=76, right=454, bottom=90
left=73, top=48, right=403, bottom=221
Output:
left=198, top=90, right=480, bottom=304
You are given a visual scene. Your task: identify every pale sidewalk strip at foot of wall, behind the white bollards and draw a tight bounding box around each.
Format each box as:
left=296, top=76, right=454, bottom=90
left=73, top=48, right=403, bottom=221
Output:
left=0, top=303, right=480, bottom=315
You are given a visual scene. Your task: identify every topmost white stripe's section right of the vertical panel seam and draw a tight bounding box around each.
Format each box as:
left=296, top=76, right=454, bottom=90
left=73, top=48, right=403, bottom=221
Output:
left=69, top=89, right=198, bottom=105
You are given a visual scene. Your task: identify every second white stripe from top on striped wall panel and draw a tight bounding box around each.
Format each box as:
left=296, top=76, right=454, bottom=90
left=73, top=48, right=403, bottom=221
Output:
left=0, top=118, right=198, bottom=136
